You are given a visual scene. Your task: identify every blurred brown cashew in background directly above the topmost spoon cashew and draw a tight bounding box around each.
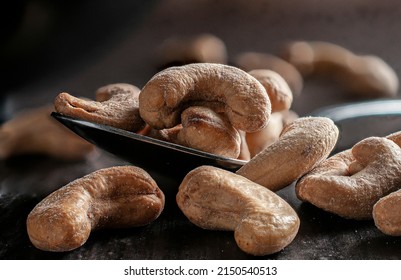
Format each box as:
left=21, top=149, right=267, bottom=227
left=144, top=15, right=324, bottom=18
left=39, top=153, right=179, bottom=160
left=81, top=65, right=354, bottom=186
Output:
left=159, top=33, right=227, bottom=66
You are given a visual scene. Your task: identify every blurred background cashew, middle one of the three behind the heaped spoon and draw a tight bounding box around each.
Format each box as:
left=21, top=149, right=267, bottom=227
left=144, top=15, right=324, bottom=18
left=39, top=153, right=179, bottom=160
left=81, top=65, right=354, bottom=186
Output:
left=234, top=52, right=304, bottom=96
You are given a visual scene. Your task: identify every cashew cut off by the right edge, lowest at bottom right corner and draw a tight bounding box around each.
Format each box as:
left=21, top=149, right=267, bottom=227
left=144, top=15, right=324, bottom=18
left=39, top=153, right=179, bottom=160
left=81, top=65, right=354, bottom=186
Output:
left=372, top=190, right=401, bottom=236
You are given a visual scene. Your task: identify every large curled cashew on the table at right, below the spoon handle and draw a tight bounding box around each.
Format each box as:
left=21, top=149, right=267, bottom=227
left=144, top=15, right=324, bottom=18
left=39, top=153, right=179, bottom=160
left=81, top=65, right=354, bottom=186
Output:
left=295, top=137, right=401, bottom=219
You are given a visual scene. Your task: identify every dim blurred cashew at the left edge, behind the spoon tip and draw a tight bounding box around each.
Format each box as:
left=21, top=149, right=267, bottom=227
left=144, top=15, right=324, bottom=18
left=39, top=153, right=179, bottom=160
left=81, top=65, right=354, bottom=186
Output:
left=0, top=105, right=95, bottom=160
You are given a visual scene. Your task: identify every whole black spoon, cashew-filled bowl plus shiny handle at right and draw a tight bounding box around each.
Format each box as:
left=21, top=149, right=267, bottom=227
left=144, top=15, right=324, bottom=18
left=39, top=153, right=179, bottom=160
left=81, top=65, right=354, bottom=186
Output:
left=52, top=100, right=401, bottom=177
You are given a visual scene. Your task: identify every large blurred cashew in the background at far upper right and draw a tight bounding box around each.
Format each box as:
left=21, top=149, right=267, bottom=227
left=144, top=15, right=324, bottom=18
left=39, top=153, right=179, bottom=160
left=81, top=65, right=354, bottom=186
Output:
left=282, top=41, right=399, bottom=98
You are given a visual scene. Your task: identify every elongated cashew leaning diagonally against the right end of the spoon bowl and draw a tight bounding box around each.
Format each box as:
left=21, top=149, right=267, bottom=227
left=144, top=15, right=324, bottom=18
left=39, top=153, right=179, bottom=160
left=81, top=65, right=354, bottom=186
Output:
left=237, top=117, right=338, bottom=191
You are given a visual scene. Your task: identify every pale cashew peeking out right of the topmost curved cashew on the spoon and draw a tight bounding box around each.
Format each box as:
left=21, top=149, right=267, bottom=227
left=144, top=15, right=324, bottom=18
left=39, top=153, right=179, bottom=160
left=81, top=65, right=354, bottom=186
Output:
left=248, top=69, right=292, bottom=112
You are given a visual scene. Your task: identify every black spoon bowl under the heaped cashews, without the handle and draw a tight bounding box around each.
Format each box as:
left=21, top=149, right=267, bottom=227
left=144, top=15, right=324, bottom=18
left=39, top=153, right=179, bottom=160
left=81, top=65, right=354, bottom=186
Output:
left=51, top=112, right=246, bottom=177
